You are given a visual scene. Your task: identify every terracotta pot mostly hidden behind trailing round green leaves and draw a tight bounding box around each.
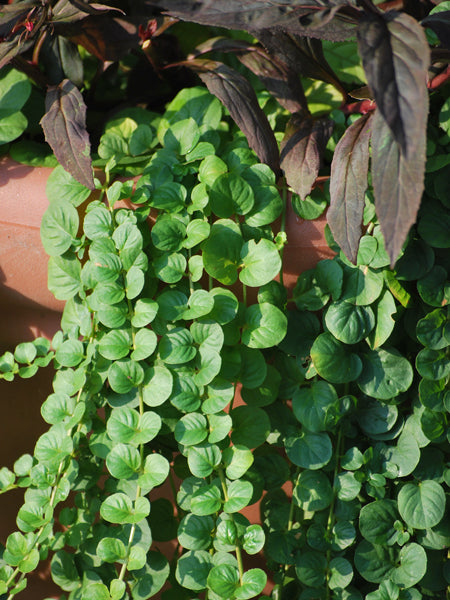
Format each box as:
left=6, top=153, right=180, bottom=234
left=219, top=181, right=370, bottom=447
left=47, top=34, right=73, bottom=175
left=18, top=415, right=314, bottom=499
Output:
left=0, top=157, right=333, bottom=600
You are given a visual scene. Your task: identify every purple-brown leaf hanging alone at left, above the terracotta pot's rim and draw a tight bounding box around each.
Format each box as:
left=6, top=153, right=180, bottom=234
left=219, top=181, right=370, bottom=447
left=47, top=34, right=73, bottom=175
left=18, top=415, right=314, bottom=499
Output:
left=41, top=79, right=94, bottom=190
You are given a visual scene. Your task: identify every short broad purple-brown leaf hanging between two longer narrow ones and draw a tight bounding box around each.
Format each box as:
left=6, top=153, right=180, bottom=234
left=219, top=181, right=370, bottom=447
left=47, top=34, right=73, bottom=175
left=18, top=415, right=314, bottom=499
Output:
left=280, top=114, right=333, bottom=200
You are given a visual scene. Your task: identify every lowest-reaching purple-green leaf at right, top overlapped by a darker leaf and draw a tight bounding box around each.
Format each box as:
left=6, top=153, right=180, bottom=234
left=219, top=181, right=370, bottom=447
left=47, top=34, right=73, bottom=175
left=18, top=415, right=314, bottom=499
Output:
left=371, top=110, right=426, bottom=265
